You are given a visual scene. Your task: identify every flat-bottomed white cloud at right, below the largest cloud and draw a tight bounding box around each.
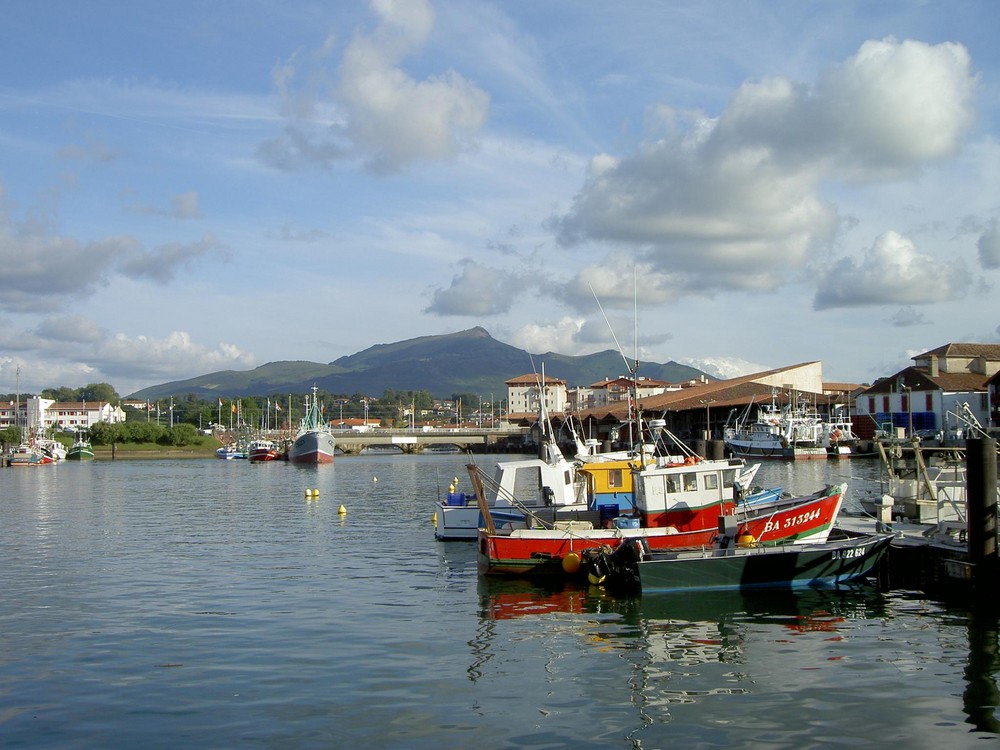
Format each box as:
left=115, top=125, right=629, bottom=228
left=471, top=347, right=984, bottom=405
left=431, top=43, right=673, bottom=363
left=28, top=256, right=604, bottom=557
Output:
left=813, top=231, right=972, bottom=310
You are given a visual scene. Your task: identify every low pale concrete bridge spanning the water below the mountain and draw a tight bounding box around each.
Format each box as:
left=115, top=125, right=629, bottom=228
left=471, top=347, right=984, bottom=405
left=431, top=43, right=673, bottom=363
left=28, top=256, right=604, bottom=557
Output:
left=334, top=427, right=528, bottom=455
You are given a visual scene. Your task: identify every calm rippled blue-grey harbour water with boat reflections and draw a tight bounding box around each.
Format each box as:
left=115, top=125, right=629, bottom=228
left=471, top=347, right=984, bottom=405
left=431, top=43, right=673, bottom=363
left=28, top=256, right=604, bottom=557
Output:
left=0, top=455, right=1000, bottom=750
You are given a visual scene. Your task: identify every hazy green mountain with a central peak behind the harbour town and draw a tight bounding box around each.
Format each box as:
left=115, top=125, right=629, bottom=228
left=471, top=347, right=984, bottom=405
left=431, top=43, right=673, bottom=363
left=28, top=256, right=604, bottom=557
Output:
left=129, top=326, right=714, bottom=401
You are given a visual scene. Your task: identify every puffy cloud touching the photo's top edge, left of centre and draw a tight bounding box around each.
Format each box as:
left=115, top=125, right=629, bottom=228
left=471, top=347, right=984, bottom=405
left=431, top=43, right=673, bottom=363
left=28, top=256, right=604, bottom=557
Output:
left=258, top=0, right=489, bottom=173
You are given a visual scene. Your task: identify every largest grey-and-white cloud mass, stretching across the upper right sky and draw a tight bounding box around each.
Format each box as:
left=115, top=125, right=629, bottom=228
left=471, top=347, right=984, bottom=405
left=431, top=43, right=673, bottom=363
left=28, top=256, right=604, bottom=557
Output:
left=556, top=39, right=976, bottom=297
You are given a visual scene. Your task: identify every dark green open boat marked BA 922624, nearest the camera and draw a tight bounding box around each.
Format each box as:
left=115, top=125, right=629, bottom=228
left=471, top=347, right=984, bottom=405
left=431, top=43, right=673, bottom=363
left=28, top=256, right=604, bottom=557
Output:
left=583, top=521, right=895, bottom=594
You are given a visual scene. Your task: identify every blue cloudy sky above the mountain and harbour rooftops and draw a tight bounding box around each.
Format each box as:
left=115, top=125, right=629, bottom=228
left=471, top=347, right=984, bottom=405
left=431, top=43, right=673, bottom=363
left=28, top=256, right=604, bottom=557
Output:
left=0, top=0, right=1000, bottom=396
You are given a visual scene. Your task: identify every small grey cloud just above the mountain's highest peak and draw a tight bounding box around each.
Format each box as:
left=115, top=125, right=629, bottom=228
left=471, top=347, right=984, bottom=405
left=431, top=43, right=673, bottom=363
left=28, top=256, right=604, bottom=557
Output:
left=424, top=258, right=530, bottom=316
